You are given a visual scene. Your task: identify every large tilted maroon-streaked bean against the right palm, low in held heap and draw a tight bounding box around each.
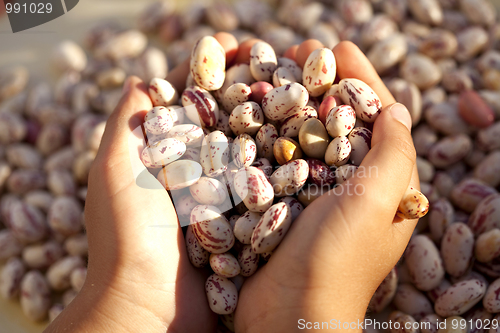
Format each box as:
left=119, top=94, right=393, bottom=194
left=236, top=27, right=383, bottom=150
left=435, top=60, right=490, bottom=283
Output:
left=252, top=202, right=292, bottom=253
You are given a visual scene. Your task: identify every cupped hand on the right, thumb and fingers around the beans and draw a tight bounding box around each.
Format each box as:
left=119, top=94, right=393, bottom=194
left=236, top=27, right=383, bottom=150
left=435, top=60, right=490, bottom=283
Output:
left=235, top=41, right=419, bottom=333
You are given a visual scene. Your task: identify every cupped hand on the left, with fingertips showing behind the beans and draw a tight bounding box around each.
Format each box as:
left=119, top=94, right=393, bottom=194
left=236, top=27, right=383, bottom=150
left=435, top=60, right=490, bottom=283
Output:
left=47, top=33, right=238, bottom=332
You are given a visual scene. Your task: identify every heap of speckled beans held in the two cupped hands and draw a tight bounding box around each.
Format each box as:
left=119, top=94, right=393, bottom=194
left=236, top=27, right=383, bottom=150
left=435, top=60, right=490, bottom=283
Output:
left=141, top=36, right=429, bottom=329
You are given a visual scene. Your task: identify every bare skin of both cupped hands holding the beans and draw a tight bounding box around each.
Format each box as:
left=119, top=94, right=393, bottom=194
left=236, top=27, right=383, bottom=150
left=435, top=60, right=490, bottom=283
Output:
left=45, top=33, right=419, bottom=333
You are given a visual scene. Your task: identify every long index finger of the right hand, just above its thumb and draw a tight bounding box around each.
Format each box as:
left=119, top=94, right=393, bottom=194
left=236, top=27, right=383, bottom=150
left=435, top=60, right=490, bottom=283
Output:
left=333, top=41, right=396, bottom=106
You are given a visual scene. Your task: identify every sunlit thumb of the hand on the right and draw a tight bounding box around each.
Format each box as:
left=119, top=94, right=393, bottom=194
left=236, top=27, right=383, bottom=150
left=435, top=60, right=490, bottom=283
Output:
left=359, top=103, right=416, bottom=221
